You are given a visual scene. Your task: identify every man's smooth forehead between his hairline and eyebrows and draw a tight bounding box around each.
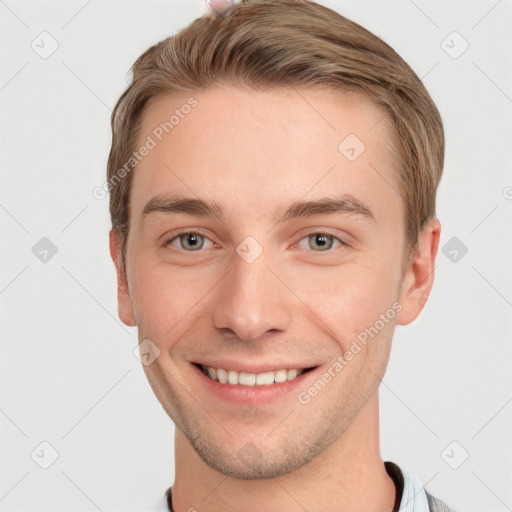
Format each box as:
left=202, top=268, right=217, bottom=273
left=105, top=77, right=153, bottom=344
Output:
left=131, top=88, right=400, bottom=224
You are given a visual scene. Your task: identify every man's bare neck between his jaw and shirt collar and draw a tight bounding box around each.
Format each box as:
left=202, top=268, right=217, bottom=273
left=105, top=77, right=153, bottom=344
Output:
left=173, top=392, right=395, bottom=512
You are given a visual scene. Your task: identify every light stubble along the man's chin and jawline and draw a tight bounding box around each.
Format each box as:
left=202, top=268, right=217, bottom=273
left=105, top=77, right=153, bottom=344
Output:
left=156, top=351, right=387, bottom=480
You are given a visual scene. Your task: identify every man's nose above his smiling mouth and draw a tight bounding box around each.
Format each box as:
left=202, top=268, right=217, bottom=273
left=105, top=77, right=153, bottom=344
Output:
left=213, top=254, right=293, bottom=341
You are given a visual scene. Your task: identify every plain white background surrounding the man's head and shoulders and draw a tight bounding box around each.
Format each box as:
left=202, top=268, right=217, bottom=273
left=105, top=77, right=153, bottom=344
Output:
left=0, top=0, right=512, bottom=512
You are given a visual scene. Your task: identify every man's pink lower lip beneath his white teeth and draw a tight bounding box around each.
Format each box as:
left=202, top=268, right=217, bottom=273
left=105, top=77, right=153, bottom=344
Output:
left=192, top=364, right=316, bottom=405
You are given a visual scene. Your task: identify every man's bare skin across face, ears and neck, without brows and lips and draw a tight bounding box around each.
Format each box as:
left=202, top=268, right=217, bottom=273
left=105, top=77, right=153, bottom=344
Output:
left=110, top=87, right=441, bottom=512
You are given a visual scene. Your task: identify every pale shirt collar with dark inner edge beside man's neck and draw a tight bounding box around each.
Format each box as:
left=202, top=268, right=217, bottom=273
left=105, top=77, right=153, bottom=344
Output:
left=152, top=462, right=444, bottom=512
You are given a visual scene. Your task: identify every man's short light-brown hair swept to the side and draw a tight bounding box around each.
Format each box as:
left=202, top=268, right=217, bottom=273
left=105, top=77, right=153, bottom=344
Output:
left=107, top=0, right=444, bottom=268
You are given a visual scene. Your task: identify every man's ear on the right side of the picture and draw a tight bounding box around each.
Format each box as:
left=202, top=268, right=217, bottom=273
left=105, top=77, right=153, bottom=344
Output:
left=397, top=218, right=441, bottom=325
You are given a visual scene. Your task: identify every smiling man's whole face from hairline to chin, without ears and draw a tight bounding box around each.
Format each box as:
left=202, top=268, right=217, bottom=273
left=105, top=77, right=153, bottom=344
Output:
left=113, top=88, right=412, bottom=478
